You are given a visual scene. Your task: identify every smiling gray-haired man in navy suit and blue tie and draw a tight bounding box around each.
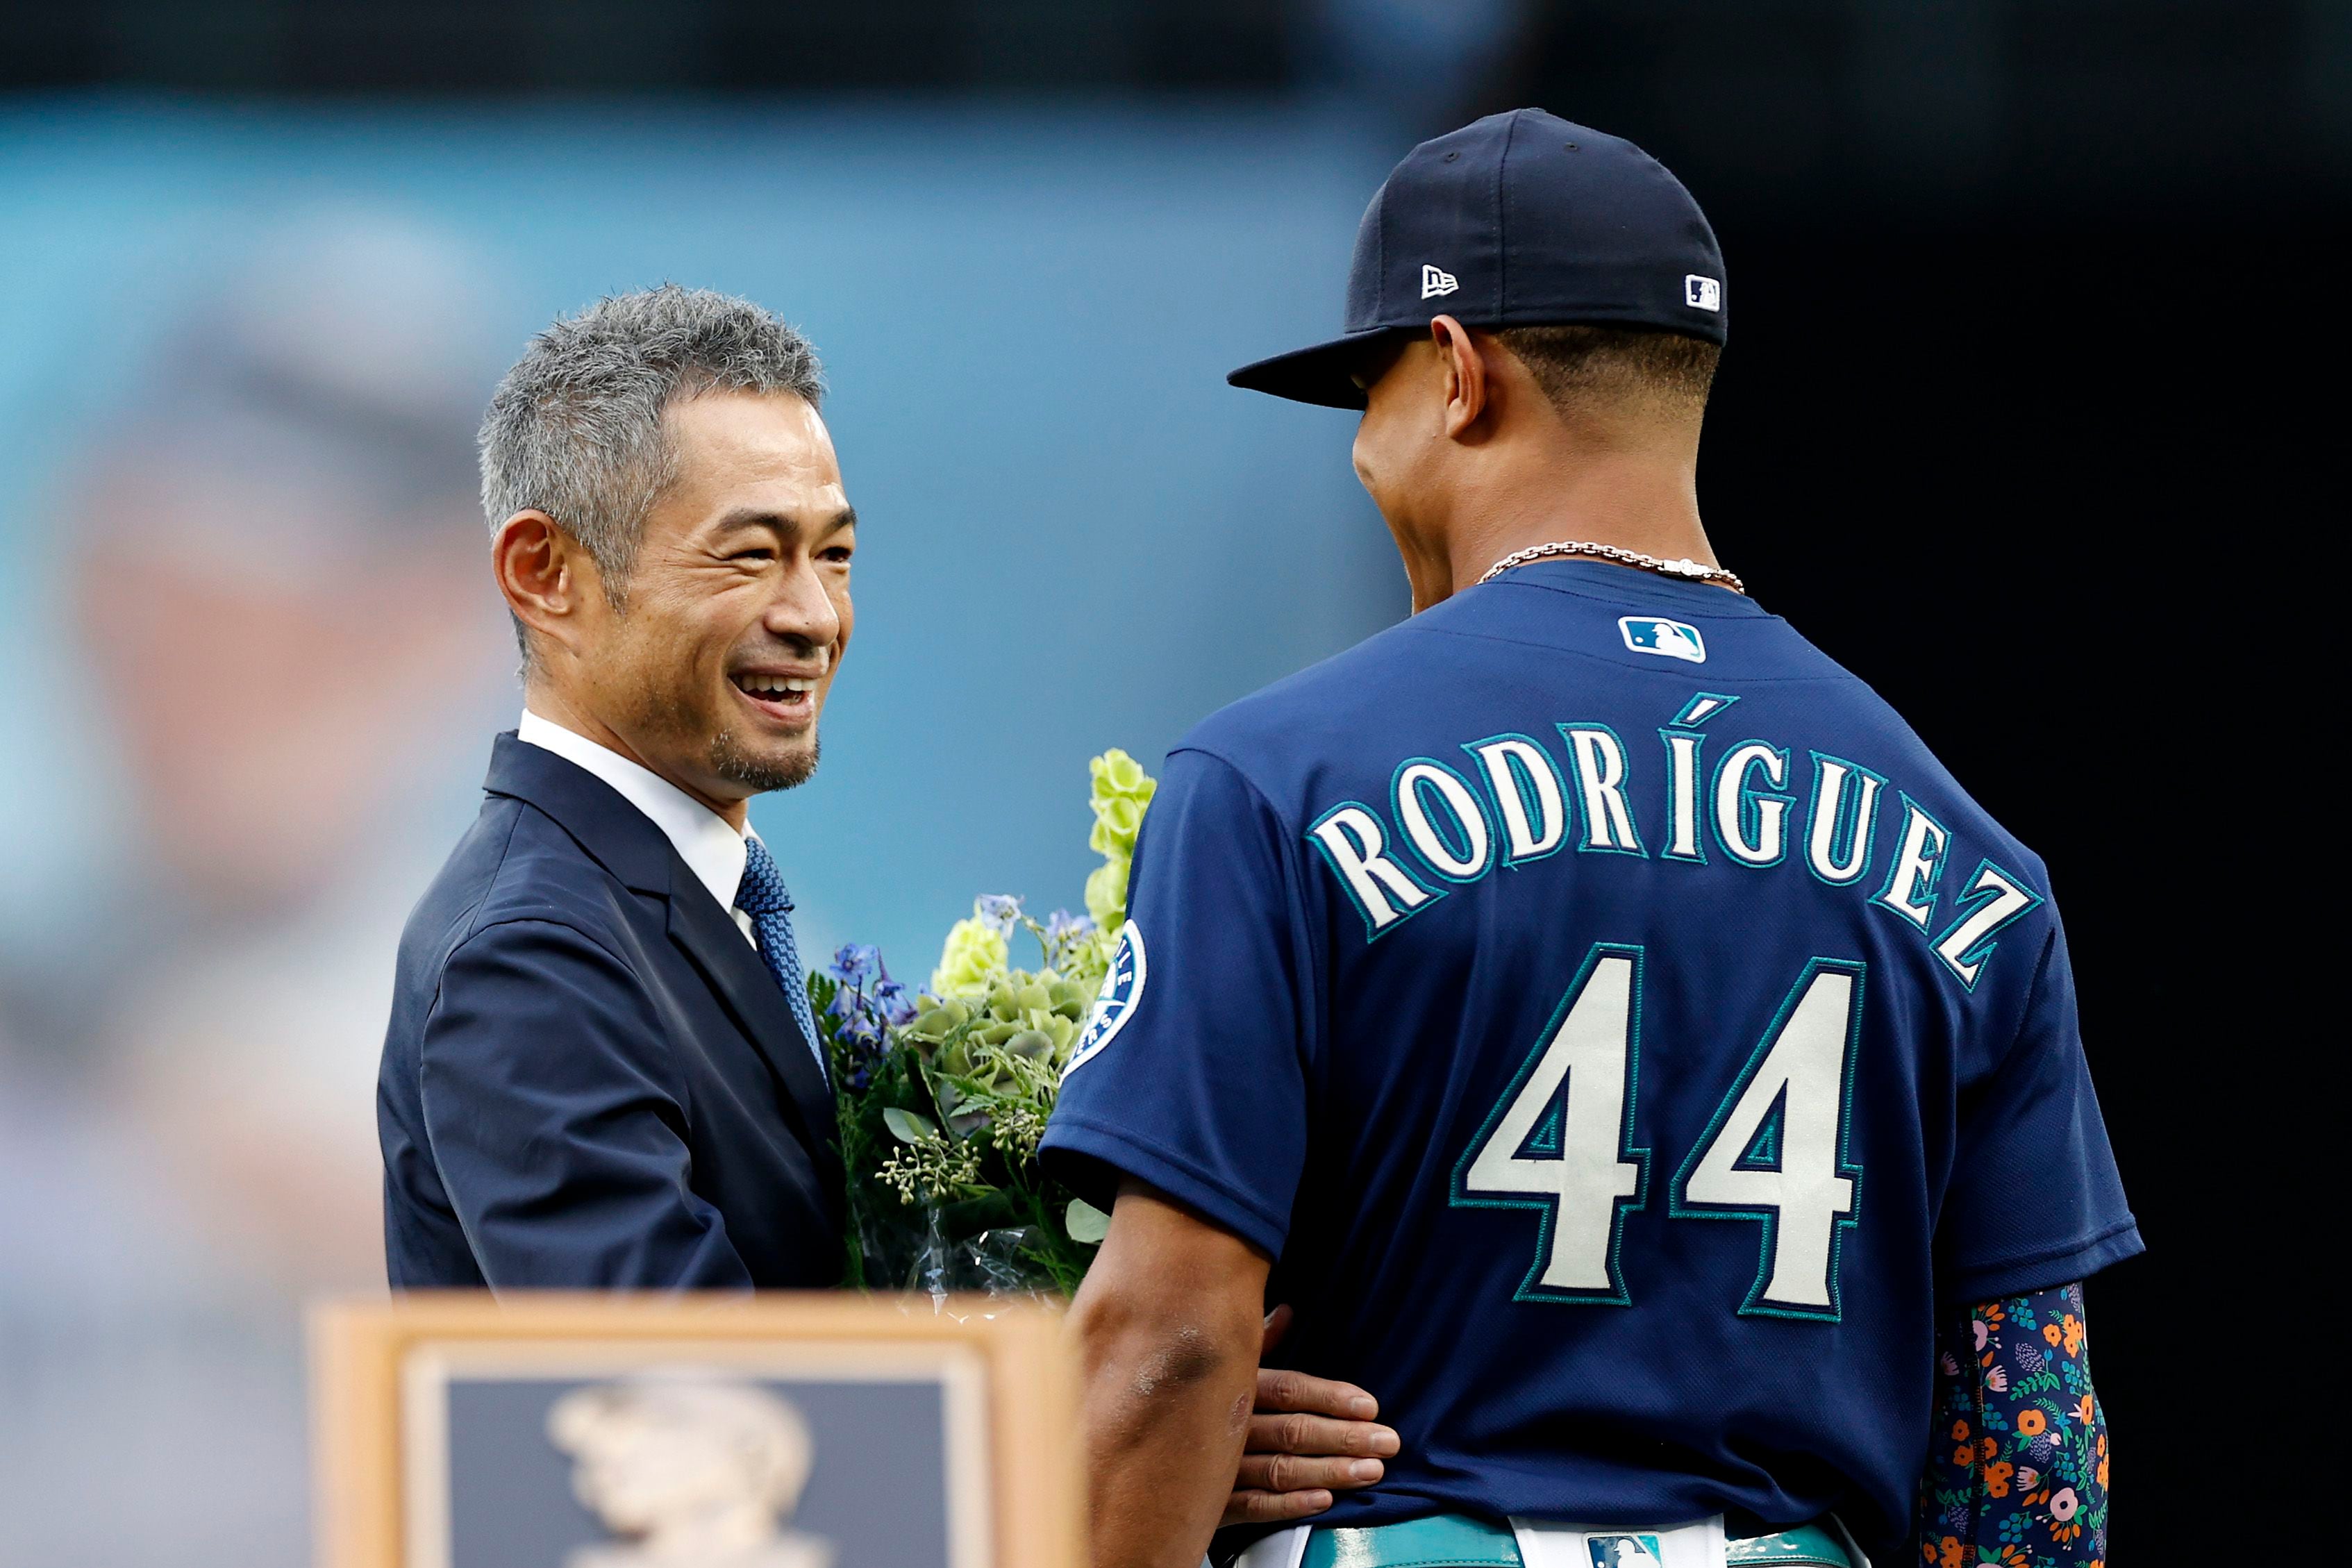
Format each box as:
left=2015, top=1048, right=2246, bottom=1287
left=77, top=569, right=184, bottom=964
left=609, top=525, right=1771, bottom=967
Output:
left=376, top=287, right=1394, bottom=1521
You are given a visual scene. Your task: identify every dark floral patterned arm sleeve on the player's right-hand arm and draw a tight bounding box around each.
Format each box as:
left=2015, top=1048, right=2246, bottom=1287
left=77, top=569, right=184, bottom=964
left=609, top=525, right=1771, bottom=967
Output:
left=1919, top=1283, right=2108, bottom=1568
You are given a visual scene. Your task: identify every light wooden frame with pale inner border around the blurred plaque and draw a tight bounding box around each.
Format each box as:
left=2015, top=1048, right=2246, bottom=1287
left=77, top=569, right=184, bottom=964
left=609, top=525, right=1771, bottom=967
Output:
left=310, top=1293, right=1084, bottom=1568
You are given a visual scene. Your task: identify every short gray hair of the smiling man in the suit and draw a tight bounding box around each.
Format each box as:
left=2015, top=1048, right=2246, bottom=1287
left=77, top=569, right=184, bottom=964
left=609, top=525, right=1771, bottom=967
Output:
left=482, top=282, right=826, bottom=615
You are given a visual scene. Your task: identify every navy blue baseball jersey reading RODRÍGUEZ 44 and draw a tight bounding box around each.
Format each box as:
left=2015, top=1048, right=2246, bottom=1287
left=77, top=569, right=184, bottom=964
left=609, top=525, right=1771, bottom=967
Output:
left=1044, top=562, right=2140, bottom=1540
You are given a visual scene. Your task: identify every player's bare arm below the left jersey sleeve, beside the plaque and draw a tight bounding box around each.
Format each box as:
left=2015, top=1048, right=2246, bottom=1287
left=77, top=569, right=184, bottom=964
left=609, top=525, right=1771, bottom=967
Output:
left=1070, top=1178, right=1270, bottom=1568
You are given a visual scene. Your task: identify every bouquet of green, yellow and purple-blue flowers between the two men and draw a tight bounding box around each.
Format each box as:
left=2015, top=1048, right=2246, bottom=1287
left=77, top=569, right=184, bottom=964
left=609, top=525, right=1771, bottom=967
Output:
left=809, top=750, right=1155, bottom=1298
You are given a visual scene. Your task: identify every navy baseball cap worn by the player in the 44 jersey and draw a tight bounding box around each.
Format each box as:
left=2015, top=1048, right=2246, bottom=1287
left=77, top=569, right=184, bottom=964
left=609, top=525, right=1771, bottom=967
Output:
left=1226, top=108, right=1726, bottom=409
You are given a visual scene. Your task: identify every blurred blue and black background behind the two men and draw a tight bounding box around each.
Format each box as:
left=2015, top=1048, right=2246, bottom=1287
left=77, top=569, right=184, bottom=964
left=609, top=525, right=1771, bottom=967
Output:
left=0, top=0, right=2324, bottom=1568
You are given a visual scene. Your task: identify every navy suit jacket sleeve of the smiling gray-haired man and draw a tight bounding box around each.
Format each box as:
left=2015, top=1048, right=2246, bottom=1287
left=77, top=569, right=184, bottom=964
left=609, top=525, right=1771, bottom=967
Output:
left=421, top=919, right=753, bottom=1291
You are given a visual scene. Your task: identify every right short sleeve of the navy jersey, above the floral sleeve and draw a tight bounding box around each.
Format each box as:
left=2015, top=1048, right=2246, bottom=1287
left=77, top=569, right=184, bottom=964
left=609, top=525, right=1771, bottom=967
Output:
left=1936, top=924, right=2143, bottom=1302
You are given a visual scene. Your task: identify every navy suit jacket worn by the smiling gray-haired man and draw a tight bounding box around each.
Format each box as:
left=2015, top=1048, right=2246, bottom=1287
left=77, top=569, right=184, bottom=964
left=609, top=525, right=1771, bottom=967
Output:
left=376, top=733, right=842, bottom=1291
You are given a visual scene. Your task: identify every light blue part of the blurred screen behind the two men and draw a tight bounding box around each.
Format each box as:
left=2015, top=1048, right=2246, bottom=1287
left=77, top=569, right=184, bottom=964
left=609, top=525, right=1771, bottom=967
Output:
left=0, top=103, right=1404, bottom=966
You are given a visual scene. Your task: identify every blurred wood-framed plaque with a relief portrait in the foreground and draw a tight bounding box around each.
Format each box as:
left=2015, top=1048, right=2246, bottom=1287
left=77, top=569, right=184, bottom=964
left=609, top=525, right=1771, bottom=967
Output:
left=310, top=1293, right=1084, bottom=1568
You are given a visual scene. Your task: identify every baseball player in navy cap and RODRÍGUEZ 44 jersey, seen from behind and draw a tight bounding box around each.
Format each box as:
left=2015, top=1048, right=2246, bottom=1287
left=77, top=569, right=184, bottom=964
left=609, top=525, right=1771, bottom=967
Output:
left=1044, top=110, right=2140, bottom=1568
